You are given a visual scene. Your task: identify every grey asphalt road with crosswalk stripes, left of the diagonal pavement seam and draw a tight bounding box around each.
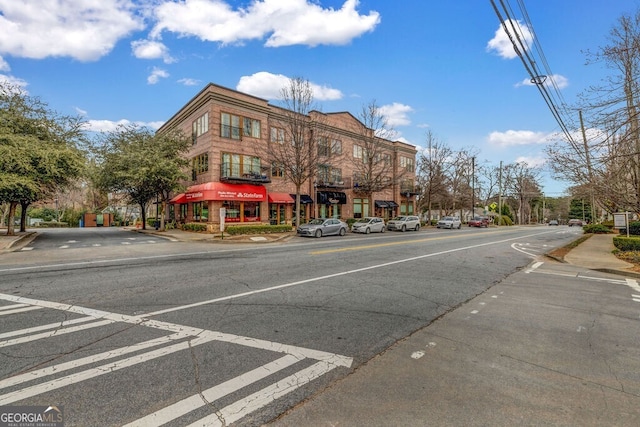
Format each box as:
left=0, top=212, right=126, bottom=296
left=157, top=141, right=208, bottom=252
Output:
left=0, top=227, right=579, bottom=426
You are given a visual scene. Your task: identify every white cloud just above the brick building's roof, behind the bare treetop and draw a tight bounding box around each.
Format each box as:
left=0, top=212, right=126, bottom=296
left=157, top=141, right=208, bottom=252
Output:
left=236, top=71, right=343, bottom=101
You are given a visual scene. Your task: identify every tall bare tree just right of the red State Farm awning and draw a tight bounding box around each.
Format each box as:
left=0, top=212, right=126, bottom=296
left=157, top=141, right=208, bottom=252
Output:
left=261, top=77, right=326, bottom=226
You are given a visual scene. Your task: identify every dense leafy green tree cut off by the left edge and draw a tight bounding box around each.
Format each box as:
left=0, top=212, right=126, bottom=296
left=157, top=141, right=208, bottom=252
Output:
left=0, top=83, right=85, bottom=235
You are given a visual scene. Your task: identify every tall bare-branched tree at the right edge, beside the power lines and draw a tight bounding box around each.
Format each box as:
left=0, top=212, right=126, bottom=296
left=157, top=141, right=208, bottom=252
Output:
left=548, top=11, right=640, bottom=217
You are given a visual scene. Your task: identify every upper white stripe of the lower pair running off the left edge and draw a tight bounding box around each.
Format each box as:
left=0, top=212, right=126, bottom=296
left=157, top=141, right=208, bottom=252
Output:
left=0, top=334, right=186, bottom=389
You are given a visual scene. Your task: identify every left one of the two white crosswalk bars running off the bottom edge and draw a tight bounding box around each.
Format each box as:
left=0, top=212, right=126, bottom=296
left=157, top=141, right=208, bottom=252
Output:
left=129, top=354, right=300, bottom=427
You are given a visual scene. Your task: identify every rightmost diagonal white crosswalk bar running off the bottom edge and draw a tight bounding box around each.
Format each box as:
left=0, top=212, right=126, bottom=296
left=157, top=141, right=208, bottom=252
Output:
left=189, top=362, right=334, bottom=427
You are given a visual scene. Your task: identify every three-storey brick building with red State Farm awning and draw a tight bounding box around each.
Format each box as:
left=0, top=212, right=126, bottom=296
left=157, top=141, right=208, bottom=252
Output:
left=158, top=84, right=417, bottom=229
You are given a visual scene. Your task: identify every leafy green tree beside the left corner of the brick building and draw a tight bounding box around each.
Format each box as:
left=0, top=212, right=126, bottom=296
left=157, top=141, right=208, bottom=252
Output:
left=96, top=126, right=191, bottom=230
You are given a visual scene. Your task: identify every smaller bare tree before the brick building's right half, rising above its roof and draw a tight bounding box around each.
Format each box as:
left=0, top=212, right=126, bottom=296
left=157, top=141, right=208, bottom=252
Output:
left=348, top=100, right=404, bottom=211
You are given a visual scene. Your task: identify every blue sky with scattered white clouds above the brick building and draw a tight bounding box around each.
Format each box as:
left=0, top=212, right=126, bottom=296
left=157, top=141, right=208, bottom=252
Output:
left=0, top=0, right=640, bottom=196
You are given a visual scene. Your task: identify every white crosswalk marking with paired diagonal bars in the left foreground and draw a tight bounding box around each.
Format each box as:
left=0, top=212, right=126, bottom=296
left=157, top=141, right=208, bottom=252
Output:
left=0, top=294, right=353, bottom=426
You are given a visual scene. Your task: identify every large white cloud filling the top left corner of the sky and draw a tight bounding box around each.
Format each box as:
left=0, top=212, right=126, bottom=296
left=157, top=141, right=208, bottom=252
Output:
left=0, top=0, right=143, bottom=61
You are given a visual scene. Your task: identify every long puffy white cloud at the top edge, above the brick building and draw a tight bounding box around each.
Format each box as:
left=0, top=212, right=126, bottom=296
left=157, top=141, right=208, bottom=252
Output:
left=151, top=0, right=380, bottom=47
